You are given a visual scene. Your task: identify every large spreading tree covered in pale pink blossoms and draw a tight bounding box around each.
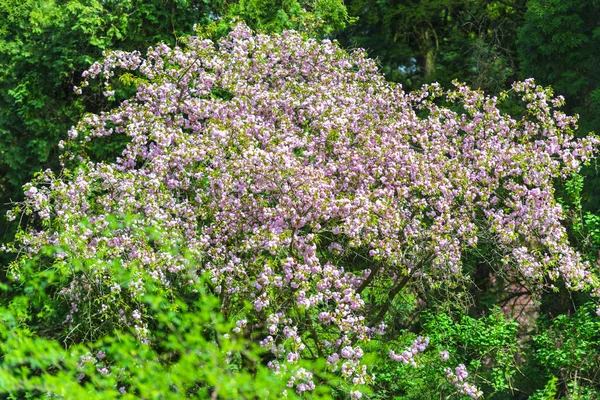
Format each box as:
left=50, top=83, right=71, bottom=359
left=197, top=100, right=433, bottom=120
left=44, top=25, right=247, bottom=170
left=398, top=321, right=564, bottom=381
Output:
left=5, top=25, right=598, bottom=397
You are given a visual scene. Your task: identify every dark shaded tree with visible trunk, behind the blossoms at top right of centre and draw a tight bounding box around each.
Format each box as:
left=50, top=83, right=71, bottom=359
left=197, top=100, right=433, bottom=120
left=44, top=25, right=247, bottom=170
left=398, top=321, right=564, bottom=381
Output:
left=341, top=0, right=524, bottom=91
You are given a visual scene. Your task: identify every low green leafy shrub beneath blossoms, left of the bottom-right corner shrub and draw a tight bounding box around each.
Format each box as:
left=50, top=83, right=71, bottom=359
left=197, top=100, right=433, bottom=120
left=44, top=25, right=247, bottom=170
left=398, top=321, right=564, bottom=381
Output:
left=360, top=309, right=521, bottom=400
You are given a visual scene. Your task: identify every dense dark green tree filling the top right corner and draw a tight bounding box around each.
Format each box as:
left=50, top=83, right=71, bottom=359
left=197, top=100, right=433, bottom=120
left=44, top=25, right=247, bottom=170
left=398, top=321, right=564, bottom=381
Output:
left=517, top=0, right=600, bottom=131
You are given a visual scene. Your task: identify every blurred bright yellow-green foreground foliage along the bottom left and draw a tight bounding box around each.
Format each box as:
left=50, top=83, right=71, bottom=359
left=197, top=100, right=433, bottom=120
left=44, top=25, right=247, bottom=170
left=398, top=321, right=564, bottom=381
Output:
left=0, top=297, right=321, bottom=399
